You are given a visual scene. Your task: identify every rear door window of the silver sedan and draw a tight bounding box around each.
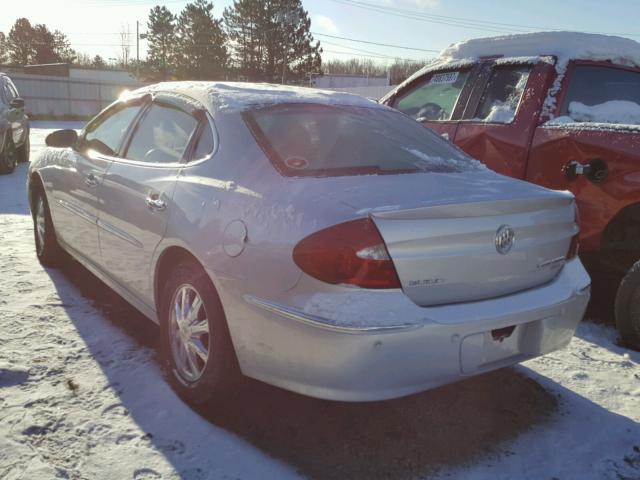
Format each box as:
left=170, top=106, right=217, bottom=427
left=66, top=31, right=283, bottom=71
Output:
left=126, top=103, right=198, bottom=163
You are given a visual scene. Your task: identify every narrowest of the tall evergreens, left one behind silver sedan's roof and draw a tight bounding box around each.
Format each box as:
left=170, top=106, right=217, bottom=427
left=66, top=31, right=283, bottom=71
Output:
left=146, top=6, right=177, bottom=80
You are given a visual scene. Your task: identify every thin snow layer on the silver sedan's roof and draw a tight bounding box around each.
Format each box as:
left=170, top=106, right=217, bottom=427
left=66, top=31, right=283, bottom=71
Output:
left=131, top=82, right=386, bottom=115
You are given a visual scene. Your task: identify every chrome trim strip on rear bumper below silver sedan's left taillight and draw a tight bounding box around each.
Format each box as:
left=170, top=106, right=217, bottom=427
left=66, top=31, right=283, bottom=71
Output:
left=243, top=295, right=422, bottom=335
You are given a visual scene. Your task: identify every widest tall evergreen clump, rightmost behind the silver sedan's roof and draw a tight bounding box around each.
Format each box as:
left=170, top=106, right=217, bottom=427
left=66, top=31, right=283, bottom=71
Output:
left=224, top=0, right=322, bottom=83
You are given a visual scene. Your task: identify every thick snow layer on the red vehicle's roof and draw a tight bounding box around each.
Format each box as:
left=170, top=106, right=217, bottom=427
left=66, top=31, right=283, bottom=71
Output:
left=439, top=32, right=640, bottom=66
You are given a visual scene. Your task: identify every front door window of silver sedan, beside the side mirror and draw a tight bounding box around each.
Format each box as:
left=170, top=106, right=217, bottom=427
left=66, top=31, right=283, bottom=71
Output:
left=83, top=103, right=141, bottom=156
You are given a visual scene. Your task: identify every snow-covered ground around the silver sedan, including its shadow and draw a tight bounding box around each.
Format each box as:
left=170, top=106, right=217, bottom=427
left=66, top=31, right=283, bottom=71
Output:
left=0, top=122, right=640, bottom=480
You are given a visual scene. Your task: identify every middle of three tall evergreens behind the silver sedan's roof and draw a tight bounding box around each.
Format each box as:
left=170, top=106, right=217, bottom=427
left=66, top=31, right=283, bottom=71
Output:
left=176, top=0, right=227, bottom=80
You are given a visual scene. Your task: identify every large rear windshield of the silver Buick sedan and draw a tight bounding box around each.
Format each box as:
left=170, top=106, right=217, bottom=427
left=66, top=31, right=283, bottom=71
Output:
left=244, top=104, right=483, bottom=176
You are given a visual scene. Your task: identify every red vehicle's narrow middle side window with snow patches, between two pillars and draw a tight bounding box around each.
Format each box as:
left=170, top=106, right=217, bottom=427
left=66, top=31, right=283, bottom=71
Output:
left=473, top=66, right=531, bottom=123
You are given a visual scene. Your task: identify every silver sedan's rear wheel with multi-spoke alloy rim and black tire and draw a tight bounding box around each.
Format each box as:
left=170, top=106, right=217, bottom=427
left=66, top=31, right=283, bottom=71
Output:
left=160, top=260, right=239, bottom=407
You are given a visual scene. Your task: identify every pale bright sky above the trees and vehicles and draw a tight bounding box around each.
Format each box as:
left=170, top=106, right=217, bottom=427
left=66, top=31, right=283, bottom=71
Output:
left=0, top=0, right=640, bottom=67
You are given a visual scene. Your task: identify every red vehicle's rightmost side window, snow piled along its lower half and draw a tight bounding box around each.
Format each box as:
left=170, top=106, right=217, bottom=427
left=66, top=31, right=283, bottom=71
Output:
left=555, top=65, right=640, bottom=125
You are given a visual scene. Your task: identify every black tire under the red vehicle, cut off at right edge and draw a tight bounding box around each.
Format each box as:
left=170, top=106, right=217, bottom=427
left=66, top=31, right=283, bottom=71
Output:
left=615, top=261, right=640, bottom=350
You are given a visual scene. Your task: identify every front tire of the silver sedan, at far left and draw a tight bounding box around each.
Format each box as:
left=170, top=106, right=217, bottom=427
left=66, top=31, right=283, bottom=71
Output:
left=33, top=187, right=68, bottom=268
